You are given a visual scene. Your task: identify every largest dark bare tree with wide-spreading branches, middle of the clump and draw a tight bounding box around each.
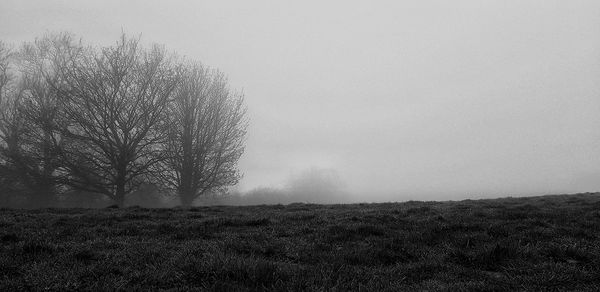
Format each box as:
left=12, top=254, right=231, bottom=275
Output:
left=54, top=35, right=179, bottom=206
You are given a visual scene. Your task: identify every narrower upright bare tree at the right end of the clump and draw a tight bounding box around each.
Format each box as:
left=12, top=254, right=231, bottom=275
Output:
left=161, top=64, right=247, bottom=206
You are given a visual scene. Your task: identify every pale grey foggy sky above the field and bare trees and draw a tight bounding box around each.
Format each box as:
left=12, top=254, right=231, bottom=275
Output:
left=0, top=0, right=600, bottom=201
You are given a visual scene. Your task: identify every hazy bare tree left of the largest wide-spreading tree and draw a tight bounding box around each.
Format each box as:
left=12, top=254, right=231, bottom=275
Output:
left=0, top=34, right=78, bottom=207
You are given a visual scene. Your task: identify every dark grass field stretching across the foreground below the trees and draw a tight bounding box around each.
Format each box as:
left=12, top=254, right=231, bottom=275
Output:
left=0, top=193, right=600, bottom=291
